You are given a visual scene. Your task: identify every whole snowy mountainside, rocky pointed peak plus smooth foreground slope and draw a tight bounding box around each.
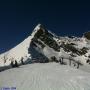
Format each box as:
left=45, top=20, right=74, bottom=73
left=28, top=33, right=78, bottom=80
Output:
left=0, top=24, right=90, bottom=90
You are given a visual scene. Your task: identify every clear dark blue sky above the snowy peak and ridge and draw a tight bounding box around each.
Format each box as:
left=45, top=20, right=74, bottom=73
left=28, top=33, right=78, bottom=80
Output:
left=0, top=0, right=90, bottom=53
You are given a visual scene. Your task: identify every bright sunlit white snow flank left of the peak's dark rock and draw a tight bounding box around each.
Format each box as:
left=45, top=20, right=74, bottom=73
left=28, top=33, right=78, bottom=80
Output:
left=0, top=24, right=40, bottom=66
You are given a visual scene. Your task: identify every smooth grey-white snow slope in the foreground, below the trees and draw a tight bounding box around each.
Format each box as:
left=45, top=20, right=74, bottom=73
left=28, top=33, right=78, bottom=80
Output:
left=0, top=63, right=90, bottom=90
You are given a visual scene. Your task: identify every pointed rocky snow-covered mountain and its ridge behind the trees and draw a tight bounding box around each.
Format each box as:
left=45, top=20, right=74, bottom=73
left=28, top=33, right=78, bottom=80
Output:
left=0, top=24, right=90, bottom=66
